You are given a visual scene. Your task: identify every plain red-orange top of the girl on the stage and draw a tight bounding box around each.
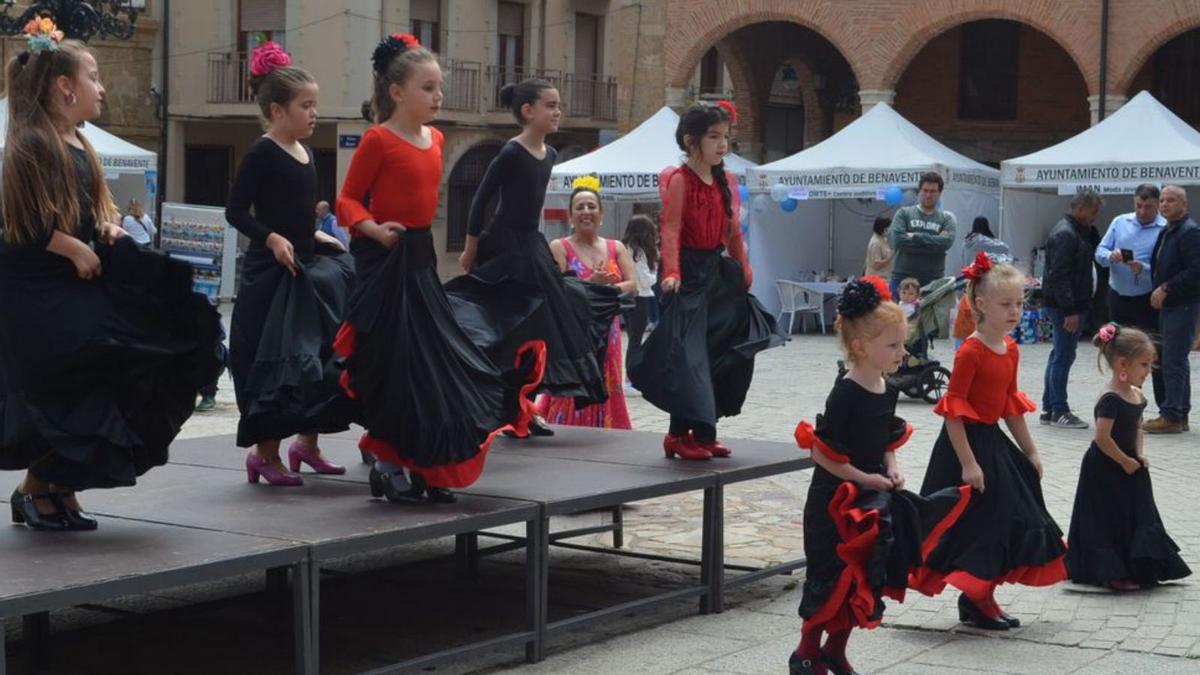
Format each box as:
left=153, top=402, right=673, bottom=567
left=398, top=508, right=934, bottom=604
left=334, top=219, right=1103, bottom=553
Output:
left=337, top=126, right=444, bottom=237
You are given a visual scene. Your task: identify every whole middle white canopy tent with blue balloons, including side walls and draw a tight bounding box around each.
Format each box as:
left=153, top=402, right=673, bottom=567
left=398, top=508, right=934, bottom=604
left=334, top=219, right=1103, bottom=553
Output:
left=748, top=103, right=1000, bottom=310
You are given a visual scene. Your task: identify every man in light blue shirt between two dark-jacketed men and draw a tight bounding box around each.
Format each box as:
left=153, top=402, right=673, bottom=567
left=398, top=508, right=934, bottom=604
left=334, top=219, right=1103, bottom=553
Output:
left=1096, top=184, right=1166, bottom=405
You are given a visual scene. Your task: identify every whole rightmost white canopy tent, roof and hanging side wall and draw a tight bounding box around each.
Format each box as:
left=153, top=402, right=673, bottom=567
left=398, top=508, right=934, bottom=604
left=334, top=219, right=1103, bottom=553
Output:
left=997, top=91, right=1200, bottom=271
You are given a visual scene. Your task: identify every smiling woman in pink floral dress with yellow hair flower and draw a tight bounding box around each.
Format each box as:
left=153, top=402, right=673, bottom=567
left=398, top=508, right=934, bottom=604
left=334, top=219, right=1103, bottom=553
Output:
left=536, top=175, right=637, bottom=429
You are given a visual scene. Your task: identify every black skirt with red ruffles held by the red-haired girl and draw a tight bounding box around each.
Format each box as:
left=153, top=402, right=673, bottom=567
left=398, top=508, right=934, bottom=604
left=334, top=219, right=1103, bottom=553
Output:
left=799, top=468, right=971, bottom=632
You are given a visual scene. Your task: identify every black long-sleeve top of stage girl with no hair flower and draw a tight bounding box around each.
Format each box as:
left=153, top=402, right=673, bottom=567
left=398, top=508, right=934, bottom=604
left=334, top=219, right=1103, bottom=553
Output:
left=467, top=141, right=558, bottom=237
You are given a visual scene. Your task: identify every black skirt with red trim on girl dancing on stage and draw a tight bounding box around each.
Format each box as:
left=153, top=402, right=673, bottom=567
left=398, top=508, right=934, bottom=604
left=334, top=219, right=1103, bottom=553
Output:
left=336, top=228, right=545, bottom=488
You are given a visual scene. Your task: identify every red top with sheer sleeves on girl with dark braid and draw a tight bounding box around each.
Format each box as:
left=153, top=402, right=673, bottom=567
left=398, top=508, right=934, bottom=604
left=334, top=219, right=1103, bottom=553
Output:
left=660, top=165, right=754, bottom=288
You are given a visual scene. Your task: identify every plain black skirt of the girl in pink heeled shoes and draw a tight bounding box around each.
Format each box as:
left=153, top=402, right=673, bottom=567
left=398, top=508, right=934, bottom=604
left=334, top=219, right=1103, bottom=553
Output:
left=229, top=240, right=356, bottom=448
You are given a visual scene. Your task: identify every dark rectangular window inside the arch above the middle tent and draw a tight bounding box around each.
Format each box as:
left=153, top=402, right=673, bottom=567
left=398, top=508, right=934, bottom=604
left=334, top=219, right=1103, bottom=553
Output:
left=959, top=19, right=1021, bottom=120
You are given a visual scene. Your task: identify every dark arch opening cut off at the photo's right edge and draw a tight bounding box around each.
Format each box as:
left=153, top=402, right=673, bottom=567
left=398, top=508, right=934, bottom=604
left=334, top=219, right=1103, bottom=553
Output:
left=1128, top=29, right=1200, bottom=129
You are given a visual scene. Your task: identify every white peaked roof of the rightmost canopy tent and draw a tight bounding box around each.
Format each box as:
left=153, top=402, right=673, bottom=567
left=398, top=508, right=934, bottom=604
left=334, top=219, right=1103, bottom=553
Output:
left=1001, top=91, right=1200, bottom=189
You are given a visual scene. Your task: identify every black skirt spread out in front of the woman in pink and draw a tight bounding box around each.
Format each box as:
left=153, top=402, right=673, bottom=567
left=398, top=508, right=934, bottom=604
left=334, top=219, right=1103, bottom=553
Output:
left=445, top=225, right=609, bottom=406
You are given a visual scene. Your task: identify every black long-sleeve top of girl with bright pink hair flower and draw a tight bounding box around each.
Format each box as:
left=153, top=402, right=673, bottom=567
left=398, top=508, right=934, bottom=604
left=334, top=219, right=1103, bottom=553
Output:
left=226, top=136, right=317, bottom=244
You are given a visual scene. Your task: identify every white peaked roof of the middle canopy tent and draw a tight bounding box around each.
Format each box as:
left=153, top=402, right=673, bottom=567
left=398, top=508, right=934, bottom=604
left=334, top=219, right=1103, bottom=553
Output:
left=746, top=103, right=1000, bottom=199
